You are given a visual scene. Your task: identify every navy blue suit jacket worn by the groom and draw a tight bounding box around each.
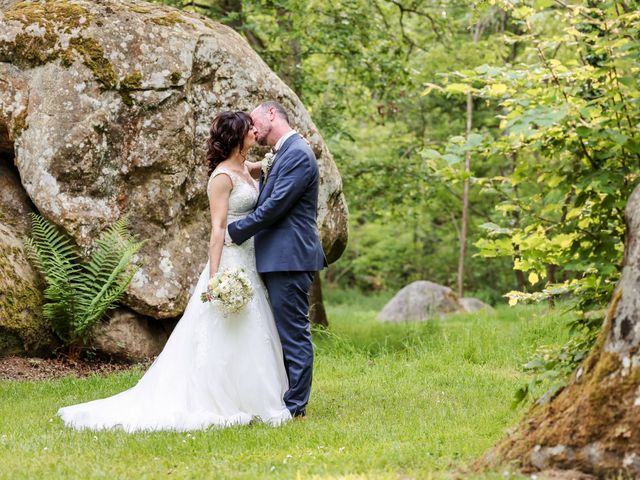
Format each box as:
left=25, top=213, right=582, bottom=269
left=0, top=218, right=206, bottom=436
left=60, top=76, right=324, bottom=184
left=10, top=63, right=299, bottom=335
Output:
left=227, top=134, right=327, bottom=273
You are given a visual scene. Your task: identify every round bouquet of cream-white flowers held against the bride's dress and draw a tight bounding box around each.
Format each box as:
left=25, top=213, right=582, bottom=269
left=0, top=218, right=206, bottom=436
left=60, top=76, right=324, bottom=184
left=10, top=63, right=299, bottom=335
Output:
left=200, top=268, right=253, bottom=313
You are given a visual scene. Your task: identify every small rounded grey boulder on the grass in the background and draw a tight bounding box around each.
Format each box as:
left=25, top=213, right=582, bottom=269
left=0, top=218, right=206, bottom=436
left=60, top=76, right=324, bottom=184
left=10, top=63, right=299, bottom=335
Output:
left=378, top=280, right=464, bottom=322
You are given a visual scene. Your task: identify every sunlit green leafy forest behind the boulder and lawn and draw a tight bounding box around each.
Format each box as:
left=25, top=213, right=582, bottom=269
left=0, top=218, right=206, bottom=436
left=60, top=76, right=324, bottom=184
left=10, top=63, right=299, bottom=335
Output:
left=154, top=0, right=640, bottom=318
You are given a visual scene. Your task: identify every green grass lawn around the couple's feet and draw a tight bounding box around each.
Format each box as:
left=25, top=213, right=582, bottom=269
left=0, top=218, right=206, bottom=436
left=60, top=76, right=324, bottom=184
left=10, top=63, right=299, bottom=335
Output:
left=0, top=292, right=566, bottom=479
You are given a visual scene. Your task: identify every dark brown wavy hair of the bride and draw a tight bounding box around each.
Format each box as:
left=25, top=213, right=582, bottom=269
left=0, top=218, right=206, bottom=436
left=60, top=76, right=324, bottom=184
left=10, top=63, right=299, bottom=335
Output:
left=207, top=111, right=252, bottom=175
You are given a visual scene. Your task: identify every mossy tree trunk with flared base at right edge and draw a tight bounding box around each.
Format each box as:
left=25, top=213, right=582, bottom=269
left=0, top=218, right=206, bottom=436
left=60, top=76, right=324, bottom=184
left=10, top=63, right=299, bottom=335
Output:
left=476, top=186, right=640, bottom=478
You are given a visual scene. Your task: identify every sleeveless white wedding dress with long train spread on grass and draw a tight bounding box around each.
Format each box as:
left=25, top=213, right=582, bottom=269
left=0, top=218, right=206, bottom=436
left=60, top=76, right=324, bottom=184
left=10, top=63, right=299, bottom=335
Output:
left=58, top=167, right=291, bottom=432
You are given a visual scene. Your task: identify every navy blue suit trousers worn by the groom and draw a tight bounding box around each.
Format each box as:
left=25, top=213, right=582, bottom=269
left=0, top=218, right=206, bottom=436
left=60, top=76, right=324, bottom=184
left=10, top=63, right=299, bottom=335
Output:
left=262, top=272, right=314, bottom=416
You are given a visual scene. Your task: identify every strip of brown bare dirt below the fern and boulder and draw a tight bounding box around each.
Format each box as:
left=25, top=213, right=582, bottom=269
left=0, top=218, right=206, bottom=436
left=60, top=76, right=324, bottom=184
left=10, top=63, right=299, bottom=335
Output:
left=0, top=357, right=151, bottom=380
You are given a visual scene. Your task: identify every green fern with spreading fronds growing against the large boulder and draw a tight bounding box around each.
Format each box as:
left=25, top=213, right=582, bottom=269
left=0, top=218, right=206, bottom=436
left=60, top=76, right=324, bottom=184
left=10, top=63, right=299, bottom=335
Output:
left=25, top=214, right=143, bottom=353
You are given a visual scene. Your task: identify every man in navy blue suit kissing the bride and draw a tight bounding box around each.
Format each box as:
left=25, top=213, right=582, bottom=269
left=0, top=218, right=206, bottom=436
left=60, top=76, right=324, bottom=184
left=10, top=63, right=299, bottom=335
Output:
left=227, top=102, right=327, bottom=417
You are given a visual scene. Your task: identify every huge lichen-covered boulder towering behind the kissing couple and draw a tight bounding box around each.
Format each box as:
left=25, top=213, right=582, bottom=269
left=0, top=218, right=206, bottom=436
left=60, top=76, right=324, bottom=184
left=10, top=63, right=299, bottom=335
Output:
left=0, top=0, right=347, bottom=318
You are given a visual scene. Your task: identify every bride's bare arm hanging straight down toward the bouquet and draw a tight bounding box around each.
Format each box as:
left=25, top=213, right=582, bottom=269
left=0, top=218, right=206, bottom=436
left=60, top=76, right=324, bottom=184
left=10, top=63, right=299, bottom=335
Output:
left=207, top=174, right=233, bottom=278
